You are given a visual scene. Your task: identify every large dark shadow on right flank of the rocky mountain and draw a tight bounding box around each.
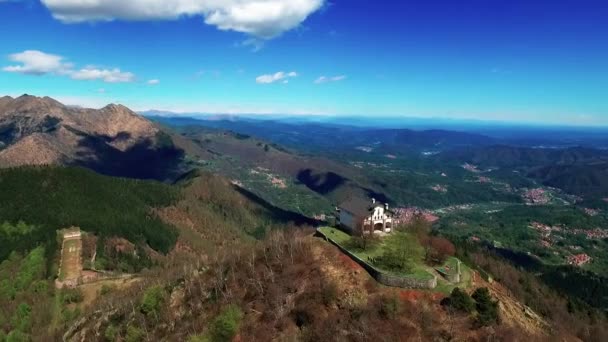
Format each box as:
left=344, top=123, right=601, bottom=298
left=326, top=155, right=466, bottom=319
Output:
left=75, top=132, right=184, bottom=181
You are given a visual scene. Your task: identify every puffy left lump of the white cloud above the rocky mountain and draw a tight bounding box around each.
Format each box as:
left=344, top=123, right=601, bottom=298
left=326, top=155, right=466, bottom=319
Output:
left=2, top=50, right=72, bottom=76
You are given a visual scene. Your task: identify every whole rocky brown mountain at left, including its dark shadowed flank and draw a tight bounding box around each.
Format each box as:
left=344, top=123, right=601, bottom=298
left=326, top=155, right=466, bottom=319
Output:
left=0, top=95, right=179, bottom=178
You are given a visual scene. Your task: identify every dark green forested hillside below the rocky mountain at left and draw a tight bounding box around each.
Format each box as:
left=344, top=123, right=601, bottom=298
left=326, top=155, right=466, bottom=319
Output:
left=0, top=167, right=178, bottom=261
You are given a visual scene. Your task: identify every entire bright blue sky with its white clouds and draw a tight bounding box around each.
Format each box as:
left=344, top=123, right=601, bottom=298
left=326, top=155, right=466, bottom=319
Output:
left=0, top=0, right=608, bottom=126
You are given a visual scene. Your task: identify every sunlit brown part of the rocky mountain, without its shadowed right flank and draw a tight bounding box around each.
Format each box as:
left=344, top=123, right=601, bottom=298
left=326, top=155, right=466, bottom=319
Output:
left=0, top=94, right=166, bottom=167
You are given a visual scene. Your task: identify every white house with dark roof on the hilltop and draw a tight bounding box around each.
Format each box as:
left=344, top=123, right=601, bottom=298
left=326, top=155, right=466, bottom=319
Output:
left=337, top=197, right=393, bottom=234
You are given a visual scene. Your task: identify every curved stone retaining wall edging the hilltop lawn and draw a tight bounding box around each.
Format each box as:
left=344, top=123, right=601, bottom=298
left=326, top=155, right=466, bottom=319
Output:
left=317, top=229, right=437, bottom=289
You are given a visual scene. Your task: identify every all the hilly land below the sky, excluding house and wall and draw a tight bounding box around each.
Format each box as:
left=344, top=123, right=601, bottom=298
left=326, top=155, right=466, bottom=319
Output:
left=0, top=97, right=608, bottom=341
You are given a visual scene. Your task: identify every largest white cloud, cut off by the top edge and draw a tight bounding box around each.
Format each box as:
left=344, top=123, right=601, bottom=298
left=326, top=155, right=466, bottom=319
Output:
left=42, top=0, right=325, bottom=39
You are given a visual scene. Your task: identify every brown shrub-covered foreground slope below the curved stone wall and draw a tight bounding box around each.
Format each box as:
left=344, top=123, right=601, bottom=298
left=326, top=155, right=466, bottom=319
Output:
left=67, top=229, right=538, bottom=341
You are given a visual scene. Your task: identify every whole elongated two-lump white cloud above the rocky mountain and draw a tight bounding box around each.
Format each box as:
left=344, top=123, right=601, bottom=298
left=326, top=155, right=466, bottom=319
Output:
left=2, top=50, right=135, bottom=83
